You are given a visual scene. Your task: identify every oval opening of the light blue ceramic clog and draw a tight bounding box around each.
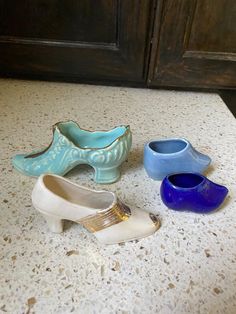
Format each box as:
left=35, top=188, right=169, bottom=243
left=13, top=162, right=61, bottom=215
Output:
left=149, top=140, right=187, bottom=154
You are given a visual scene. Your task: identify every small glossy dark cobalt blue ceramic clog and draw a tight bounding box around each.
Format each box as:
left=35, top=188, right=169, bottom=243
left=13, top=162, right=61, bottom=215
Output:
left=161, top=173, right=228, bottom=213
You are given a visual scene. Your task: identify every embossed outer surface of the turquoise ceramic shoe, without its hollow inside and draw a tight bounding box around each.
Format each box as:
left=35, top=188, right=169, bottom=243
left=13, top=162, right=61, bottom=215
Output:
left=13, top=121, right=132, bottom=183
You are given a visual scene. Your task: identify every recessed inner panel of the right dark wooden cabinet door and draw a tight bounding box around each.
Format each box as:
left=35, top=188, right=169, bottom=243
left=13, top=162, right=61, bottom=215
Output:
left=187, top=0, right=236, bottom=54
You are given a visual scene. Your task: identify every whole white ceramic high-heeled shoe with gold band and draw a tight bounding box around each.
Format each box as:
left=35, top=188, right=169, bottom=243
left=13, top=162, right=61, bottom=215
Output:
left=32, top=174, right=160, bottom=244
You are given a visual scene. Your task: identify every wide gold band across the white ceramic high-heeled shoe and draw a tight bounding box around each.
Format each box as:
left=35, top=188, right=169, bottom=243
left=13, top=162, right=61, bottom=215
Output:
left=77, top=201, right=131, bottom=233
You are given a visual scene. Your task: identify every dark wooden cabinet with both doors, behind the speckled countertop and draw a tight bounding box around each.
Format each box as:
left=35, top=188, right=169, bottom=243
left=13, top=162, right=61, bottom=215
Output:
left=0, top=0, right=236, bottom=89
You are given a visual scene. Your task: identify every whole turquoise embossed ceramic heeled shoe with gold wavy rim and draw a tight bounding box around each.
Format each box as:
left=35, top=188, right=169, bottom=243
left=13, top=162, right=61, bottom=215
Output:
left=12, top=121, right=132, bottom=183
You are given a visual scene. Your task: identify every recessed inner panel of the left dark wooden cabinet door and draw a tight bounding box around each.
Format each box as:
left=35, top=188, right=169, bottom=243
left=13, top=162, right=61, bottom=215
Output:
left=0, top=0, right=118, bottom=43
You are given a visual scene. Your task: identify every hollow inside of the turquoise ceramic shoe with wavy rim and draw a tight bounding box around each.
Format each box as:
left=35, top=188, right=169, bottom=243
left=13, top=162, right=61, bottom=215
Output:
left=58, top=122, right=126, bottom=149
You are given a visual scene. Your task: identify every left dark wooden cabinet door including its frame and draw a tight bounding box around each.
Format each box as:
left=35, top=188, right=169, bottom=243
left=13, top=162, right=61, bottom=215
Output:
left=0, top=0, right=152, bottom=82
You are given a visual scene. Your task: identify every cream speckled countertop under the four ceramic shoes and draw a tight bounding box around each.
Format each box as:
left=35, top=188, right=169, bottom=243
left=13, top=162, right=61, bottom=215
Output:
left=0, top=80, right=236, bottom=314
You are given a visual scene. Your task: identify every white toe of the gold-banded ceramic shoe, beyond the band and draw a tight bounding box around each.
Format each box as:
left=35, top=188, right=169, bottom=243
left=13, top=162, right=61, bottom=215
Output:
left=94, top=209, right=161, bottom=244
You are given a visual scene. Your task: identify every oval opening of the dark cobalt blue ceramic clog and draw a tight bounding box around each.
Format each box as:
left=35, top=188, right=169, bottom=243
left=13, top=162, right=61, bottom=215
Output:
left=169, top=173, right=203, bottom=188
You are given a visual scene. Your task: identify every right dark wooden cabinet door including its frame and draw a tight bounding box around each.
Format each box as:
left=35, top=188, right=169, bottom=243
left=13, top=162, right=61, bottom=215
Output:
left=148, top=0, right=236, bottom=88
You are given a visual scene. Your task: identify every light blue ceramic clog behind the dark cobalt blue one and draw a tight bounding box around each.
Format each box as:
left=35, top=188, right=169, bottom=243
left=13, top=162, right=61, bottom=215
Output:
left=144, top=138, right=211, bottom=180
